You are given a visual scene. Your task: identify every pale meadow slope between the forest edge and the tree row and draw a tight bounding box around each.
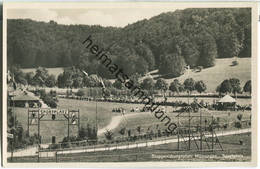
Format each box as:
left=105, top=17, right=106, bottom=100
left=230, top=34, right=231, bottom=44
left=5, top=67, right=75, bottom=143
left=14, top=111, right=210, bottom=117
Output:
left=21, top=58, right=251, bottom=93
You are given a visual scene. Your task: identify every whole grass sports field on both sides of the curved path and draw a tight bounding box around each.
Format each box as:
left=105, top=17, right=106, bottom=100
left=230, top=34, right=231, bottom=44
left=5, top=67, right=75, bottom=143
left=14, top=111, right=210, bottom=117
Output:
left=14, top=96, right=250, bottom=143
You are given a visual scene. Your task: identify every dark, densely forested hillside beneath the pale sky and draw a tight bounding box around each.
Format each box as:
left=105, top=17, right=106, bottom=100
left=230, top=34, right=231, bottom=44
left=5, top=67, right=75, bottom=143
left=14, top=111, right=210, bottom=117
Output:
left=7, top=8, right=251, bottom=78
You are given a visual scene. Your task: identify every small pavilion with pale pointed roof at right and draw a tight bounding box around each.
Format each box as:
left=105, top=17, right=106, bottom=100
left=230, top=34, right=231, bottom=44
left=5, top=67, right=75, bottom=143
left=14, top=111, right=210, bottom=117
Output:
left=217, top=95, right=236, bottom=110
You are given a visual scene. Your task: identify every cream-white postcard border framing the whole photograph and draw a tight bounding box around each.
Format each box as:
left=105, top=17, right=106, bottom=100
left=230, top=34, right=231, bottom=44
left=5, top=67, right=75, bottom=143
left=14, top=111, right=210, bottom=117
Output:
left=2, top=2, right=258, bottom=168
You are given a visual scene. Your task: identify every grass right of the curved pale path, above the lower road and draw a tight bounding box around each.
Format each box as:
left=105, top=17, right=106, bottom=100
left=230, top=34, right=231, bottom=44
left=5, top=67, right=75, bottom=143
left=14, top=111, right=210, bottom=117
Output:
left=113, top=111, right=251, bottom=137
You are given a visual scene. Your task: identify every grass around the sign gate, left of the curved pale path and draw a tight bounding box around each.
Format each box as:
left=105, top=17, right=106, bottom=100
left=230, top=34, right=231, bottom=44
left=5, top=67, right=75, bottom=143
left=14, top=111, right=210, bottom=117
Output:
left=14, top=99, right=112, bottom=143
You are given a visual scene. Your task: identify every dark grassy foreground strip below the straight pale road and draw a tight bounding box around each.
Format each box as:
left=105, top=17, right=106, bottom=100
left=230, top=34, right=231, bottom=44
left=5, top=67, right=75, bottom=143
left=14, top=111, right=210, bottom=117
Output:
left=9, top=133, right=251, bottom=162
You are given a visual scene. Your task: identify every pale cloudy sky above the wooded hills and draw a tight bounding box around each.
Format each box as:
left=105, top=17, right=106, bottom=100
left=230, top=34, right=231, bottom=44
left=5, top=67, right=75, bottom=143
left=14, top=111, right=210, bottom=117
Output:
left=7, top=8, right=183, bottom=27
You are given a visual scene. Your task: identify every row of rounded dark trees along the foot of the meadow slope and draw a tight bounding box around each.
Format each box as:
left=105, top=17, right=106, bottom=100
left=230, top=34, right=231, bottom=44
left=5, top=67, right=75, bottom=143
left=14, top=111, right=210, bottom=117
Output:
left=9, top=66, right=252, bottom=98
